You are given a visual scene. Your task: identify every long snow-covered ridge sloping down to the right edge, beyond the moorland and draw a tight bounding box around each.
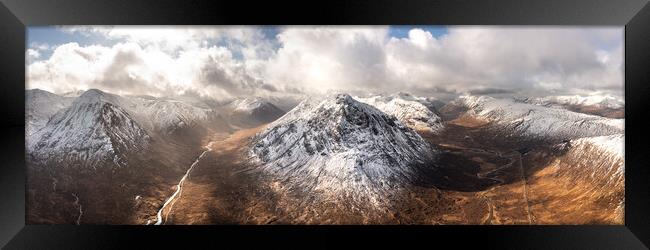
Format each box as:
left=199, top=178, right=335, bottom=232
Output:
left=454, top=96, right=624, bottom=139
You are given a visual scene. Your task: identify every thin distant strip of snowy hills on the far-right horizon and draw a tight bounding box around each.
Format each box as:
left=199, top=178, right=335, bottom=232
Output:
left=524, top=94, right=625, bottom=109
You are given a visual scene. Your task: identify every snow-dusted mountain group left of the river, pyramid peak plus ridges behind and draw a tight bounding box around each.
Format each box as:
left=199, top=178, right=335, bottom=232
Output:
left=25, top=89, right=235, bottom=169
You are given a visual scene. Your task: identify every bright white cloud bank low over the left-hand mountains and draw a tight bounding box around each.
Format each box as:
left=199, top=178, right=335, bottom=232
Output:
left=27, top=39, right=274, bottom=98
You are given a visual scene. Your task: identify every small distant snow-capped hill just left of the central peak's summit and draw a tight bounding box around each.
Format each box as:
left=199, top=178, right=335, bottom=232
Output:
left=226, top=97, right=285, bottom=127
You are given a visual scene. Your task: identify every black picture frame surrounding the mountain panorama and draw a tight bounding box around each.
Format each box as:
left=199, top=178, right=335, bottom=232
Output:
left=0, top=0, right=650, bottom=249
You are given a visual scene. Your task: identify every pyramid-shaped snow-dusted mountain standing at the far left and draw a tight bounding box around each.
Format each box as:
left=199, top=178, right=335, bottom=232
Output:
left=27, top=90, right=150, bottom=167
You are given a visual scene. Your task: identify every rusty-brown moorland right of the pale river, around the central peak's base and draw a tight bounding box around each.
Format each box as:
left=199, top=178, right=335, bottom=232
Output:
left=144, top=118, right=623, bottom=224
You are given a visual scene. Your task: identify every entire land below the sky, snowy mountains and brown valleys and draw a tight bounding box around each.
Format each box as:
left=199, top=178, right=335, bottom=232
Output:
left=25, top=89, right=625, bottom=225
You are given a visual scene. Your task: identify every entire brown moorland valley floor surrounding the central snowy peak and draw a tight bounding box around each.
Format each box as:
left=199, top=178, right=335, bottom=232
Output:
left=27, top=117, right=624, bottom=225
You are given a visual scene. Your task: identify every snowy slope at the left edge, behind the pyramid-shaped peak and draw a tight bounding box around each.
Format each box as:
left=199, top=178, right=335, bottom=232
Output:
left=25, top=89, right=74, bottom=136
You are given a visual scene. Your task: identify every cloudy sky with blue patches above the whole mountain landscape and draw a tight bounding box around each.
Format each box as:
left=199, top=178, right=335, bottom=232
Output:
left=25, top=26, right=624, bottom=99
